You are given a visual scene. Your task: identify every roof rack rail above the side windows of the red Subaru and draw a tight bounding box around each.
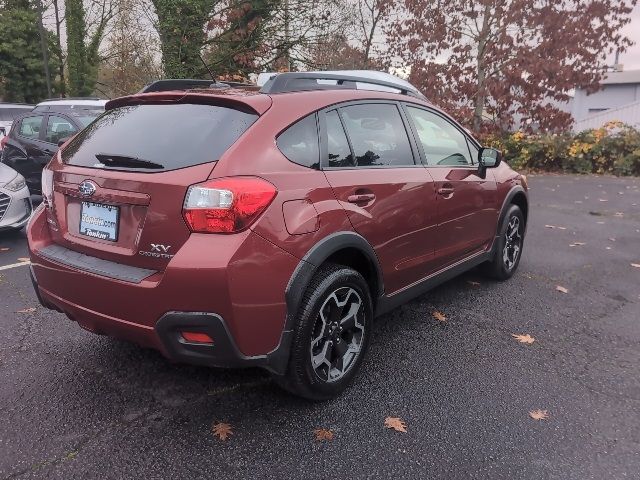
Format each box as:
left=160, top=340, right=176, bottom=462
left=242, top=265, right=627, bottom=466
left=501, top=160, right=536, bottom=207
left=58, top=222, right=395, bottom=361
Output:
left=260, top=71, right=425, bottom=99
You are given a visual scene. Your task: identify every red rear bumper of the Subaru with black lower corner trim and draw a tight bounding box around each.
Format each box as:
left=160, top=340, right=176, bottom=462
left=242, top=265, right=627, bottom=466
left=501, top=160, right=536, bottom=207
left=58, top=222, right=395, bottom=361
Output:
left=27, top=204, right=298, bottom=373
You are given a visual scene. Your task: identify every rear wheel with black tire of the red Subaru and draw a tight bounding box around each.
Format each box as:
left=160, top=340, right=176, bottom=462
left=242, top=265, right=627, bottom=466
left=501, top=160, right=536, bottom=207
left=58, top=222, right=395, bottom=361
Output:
left=274, top=265, right=373, bottom=401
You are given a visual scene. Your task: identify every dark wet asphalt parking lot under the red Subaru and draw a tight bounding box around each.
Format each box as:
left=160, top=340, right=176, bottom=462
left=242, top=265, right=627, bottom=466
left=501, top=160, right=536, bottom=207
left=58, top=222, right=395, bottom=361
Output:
left=0, top=175, right=640, bottom=480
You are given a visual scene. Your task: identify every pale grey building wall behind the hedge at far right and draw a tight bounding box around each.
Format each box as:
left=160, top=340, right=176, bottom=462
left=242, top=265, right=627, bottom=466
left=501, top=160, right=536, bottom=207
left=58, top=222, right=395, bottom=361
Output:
left=572, top=83, right=640, bottom=122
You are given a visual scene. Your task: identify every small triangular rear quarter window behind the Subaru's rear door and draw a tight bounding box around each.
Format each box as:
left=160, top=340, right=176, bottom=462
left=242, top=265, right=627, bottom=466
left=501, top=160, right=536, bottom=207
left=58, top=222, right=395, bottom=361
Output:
left=276, top=113, right=320, bottom=168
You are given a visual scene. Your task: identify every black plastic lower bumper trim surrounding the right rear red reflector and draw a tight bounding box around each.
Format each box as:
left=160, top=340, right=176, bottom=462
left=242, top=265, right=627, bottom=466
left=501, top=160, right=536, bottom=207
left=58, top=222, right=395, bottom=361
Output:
left=156, top=312, right=292, bottom=375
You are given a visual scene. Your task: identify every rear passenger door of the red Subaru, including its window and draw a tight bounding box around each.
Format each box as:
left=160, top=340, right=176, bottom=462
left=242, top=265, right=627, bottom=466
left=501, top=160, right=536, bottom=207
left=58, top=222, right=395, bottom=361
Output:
left=320, top=102, right=436, bottom=294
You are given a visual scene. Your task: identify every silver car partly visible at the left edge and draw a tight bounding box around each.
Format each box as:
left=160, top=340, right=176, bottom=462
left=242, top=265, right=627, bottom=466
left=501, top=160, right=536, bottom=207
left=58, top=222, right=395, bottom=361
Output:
left=0, top=163, right=32, bottom=231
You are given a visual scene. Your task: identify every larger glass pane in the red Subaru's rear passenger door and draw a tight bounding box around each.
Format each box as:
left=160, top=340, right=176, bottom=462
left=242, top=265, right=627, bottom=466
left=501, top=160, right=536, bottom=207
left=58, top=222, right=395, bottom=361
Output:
left=340, top=103, right=415, bottom=167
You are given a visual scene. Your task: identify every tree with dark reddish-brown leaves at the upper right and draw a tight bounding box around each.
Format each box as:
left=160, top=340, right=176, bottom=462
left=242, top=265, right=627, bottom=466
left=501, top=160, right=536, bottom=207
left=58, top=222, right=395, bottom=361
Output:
left=386, top=0, right=636, bottom=131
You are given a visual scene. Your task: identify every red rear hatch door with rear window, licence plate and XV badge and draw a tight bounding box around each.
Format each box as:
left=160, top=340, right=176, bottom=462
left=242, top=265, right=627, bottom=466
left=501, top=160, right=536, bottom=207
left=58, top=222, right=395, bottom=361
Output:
left=48, top=98, right=258, bottom=270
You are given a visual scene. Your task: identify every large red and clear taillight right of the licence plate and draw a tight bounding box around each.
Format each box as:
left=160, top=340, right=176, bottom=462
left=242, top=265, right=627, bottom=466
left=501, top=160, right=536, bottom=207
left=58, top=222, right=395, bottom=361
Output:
left=182, top=177, right=277, bottom=233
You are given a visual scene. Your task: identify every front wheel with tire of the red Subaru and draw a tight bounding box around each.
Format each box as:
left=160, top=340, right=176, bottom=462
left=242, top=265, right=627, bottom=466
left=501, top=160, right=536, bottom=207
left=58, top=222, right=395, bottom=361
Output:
left=482, top=205, right=525, bottom=281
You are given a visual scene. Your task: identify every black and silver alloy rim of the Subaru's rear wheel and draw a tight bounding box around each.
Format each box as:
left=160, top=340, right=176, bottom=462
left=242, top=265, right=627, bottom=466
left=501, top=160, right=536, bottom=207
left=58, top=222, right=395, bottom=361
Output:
left=310, top=287, right=365, bottom=383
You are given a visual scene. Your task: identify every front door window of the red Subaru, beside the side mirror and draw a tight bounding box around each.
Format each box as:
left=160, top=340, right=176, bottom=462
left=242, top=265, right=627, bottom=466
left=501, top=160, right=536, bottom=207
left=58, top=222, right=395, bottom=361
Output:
left=407, top=107, right=473, bottom=166
